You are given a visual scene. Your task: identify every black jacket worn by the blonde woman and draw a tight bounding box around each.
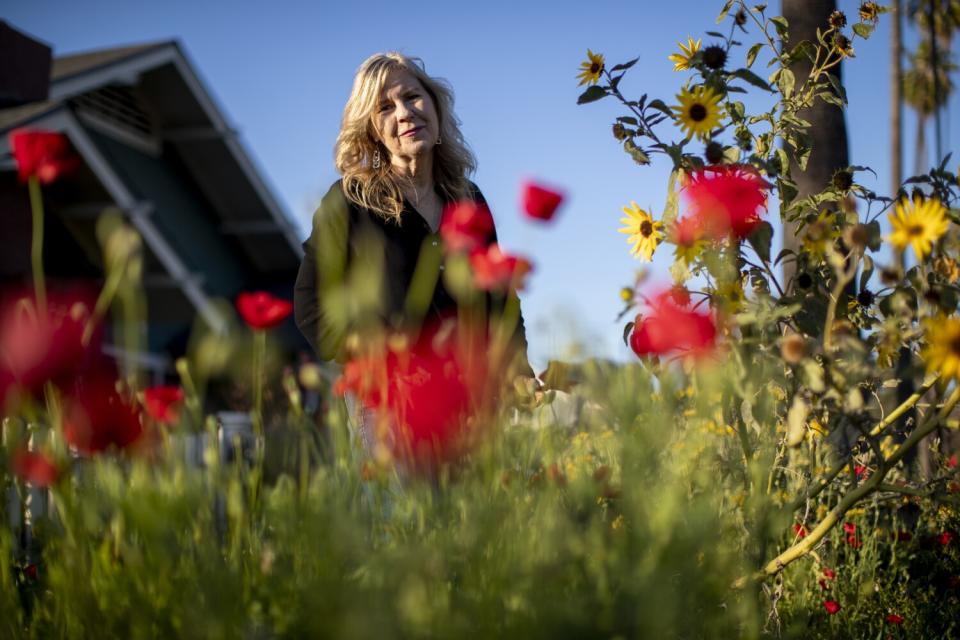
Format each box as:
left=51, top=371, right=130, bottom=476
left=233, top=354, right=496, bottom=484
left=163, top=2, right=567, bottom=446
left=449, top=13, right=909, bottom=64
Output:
left=293, top=181, right=533, bottom=376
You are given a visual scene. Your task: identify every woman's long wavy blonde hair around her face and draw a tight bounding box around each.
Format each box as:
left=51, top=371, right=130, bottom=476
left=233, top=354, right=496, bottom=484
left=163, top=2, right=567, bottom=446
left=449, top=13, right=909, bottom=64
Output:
left=334, top=51, right=476, bottom=222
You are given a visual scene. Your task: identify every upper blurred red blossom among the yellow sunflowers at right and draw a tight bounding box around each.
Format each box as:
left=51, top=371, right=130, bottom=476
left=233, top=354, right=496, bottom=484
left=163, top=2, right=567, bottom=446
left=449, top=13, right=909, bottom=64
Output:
left=684, top=165, right=767, bottom=240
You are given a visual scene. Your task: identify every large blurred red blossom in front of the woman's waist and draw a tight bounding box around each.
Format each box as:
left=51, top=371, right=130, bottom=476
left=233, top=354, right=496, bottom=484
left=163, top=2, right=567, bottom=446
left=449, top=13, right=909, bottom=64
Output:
left=334, top=329, right=497, bottom=470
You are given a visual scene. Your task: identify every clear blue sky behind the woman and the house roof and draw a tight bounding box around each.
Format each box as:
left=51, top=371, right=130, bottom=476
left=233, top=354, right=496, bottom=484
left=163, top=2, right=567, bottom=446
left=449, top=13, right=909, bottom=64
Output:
left=9, top=0, right=960, bottom=367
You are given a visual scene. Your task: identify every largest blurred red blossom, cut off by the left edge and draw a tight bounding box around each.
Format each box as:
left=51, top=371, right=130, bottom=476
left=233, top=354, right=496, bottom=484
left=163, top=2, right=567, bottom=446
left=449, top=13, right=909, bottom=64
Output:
left=0, top=290, right=100, bottom=404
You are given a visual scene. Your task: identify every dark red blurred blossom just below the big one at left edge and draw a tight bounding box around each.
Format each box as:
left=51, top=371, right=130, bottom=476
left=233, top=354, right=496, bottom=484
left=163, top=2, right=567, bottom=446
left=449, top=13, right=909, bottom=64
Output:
left=63, top=379, right=143, bottom=454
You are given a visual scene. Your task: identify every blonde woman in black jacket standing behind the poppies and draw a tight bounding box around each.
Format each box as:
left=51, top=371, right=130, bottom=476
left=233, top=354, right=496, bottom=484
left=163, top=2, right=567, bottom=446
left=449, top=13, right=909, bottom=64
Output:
left=294, top=53, right=533, bottom=460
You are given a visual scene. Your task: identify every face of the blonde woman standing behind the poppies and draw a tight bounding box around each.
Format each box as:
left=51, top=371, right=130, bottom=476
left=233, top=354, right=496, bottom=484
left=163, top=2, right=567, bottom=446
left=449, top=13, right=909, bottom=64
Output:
left=373, top=69, right=440, bottom=163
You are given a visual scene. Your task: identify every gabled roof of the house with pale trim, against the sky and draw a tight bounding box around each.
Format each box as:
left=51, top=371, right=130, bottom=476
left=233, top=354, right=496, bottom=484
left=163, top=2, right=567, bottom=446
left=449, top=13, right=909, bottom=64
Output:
left=0, top=41, right=302, bottom=272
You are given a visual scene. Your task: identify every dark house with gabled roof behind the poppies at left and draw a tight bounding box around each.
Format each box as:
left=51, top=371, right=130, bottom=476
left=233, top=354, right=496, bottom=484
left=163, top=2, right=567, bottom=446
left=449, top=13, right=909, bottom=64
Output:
left=0, top=21, right=309, bottom=378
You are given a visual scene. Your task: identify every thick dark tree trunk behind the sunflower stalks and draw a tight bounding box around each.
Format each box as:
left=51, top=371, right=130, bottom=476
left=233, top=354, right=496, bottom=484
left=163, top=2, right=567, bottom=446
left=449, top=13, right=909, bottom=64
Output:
left=781, top=0, right=850, bottom=282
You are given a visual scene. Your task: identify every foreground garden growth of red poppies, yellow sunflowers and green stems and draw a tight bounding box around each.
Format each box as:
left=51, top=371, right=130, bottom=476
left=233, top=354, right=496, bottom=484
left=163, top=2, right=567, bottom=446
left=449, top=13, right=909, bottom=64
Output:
left=0, top=0, right=960, bottom=638
